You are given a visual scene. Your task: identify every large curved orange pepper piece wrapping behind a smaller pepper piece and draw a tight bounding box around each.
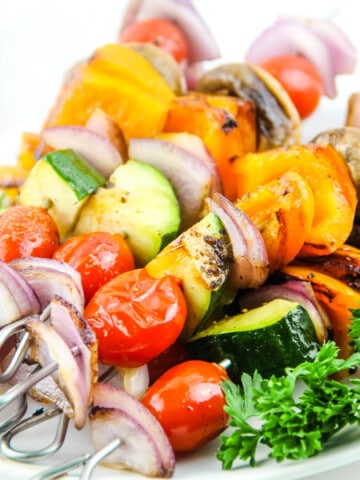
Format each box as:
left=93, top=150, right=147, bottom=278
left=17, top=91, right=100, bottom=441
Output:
left=234, top=145, right=357, bottom=256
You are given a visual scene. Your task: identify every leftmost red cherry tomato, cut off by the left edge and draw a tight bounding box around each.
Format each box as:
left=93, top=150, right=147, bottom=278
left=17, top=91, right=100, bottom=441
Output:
left=0, top=205, right=59, bottom=262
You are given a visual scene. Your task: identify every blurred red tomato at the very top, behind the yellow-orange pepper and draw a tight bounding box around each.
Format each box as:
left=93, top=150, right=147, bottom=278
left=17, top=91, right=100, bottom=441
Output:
left=119, top=18, right=189, bottom=63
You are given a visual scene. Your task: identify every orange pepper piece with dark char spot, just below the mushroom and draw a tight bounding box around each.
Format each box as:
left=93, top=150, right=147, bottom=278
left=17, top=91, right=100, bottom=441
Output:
left=164, top=93, right=256, bottom=201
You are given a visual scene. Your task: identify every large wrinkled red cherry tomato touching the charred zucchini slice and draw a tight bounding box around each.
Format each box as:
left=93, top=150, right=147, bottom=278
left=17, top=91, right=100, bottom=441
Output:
left=84, top=268, right=187, bottom=367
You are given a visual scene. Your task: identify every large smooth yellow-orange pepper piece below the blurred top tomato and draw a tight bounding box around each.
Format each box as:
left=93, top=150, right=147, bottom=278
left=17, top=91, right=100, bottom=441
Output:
left=44, top=44, right=174, bottom=141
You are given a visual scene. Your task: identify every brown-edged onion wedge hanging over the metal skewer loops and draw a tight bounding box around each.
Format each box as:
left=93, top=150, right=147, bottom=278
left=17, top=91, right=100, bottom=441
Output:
left=26, top=310, right=88, bottom=429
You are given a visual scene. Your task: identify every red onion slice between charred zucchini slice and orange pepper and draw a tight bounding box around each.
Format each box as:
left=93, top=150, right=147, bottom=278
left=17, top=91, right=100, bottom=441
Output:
left=208, top=193, right=269, bottom=289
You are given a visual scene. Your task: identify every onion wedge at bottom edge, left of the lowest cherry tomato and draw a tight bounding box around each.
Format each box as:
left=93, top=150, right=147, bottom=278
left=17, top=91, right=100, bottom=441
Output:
left=90, top=383, right=175, bottom=478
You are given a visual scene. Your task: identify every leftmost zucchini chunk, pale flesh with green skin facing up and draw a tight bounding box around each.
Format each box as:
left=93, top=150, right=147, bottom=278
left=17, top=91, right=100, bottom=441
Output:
left=19, top=149, right=106, bottom=241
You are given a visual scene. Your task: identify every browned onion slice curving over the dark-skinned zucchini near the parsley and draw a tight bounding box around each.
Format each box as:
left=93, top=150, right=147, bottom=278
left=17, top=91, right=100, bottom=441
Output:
left=239, top=280, right=331, bottom=343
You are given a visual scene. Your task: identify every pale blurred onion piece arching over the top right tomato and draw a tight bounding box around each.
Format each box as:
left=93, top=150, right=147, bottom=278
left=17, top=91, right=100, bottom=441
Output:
left=245, top=18, right=356, bottom=98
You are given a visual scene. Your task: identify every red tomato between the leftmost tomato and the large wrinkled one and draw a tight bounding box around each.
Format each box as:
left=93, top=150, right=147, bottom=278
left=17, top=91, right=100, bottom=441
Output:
left=53, top=232, right=134, bottom=302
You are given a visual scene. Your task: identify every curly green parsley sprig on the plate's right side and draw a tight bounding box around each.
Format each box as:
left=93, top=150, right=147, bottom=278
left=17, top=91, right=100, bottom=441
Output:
left=217, top=309, right=360, bottom=469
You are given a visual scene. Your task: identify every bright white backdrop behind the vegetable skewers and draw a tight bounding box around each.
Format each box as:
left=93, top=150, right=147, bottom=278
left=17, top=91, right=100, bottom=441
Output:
left=0, top=0, right=360, bottom=480
